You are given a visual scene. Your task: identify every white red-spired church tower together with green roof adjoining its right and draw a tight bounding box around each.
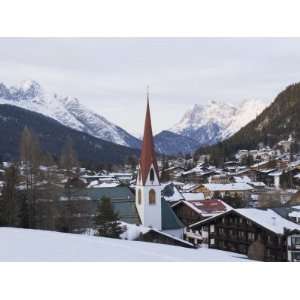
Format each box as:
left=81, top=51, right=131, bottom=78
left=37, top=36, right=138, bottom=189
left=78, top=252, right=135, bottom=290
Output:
left=135, top=93, right=184, bottom=238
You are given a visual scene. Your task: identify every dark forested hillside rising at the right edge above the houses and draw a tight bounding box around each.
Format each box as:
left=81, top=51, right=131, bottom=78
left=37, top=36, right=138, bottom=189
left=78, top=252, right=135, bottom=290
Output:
left=197, top=83, right=300, bottom=164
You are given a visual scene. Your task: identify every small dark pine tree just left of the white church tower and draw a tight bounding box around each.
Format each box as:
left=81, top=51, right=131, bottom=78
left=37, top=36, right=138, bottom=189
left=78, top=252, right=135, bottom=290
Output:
left=95, top=197, right=124, bottom=238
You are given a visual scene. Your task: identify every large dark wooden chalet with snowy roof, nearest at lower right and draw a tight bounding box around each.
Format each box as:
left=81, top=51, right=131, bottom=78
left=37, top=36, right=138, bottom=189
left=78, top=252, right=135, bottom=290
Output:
left=185, top=208, right=300, bottom=261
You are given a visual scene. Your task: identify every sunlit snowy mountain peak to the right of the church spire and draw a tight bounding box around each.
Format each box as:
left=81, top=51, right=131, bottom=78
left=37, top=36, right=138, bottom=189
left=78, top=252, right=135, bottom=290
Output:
left=170, top=100, right=266, bottom=145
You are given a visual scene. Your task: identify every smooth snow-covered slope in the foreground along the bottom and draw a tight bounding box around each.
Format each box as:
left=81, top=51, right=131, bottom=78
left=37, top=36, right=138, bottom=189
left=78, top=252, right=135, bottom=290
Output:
left=0, top=228, right=249, bottom=261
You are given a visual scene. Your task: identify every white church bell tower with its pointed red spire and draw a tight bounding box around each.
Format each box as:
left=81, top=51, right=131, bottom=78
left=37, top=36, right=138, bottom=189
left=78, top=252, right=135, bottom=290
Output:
left=135, top=92, right=162, bottom=230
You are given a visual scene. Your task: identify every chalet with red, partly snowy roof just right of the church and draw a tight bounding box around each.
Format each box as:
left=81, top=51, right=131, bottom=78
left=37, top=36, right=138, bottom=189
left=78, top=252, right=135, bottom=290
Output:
left=171, top=199, right=232, bottom=226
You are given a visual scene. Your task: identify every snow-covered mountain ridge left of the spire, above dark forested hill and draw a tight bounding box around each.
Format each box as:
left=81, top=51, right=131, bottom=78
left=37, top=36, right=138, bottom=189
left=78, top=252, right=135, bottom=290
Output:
left=0, top=80, right=140, bottom=148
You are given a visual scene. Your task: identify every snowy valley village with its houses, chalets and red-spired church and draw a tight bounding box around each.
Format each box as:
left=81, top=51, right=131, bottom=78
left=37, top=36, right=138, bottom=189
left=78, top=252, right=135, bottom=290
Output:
left=0, top=103, right=300, bottom=261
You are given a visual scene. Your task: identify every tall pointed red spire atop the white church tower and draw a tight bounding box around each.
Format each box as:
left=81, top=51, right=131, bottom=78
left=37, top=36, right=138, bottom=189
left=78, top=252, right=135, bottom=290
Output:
left=140, top=91, right=159, bottom=185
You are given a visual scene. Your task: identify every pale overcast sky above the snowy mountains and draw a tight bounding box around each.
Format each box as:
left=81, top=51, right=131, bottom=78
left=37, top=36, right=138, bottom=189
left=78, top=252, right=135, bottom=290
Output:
left=0, top=38, right=300, bottom=134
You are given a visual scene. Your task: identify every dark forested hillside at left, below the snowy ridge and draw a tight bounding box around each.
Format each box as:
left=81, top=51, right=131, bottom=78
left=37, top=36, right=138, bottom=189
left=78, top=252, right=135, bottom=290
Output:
left=0, top=105, right=139, bottom=163
